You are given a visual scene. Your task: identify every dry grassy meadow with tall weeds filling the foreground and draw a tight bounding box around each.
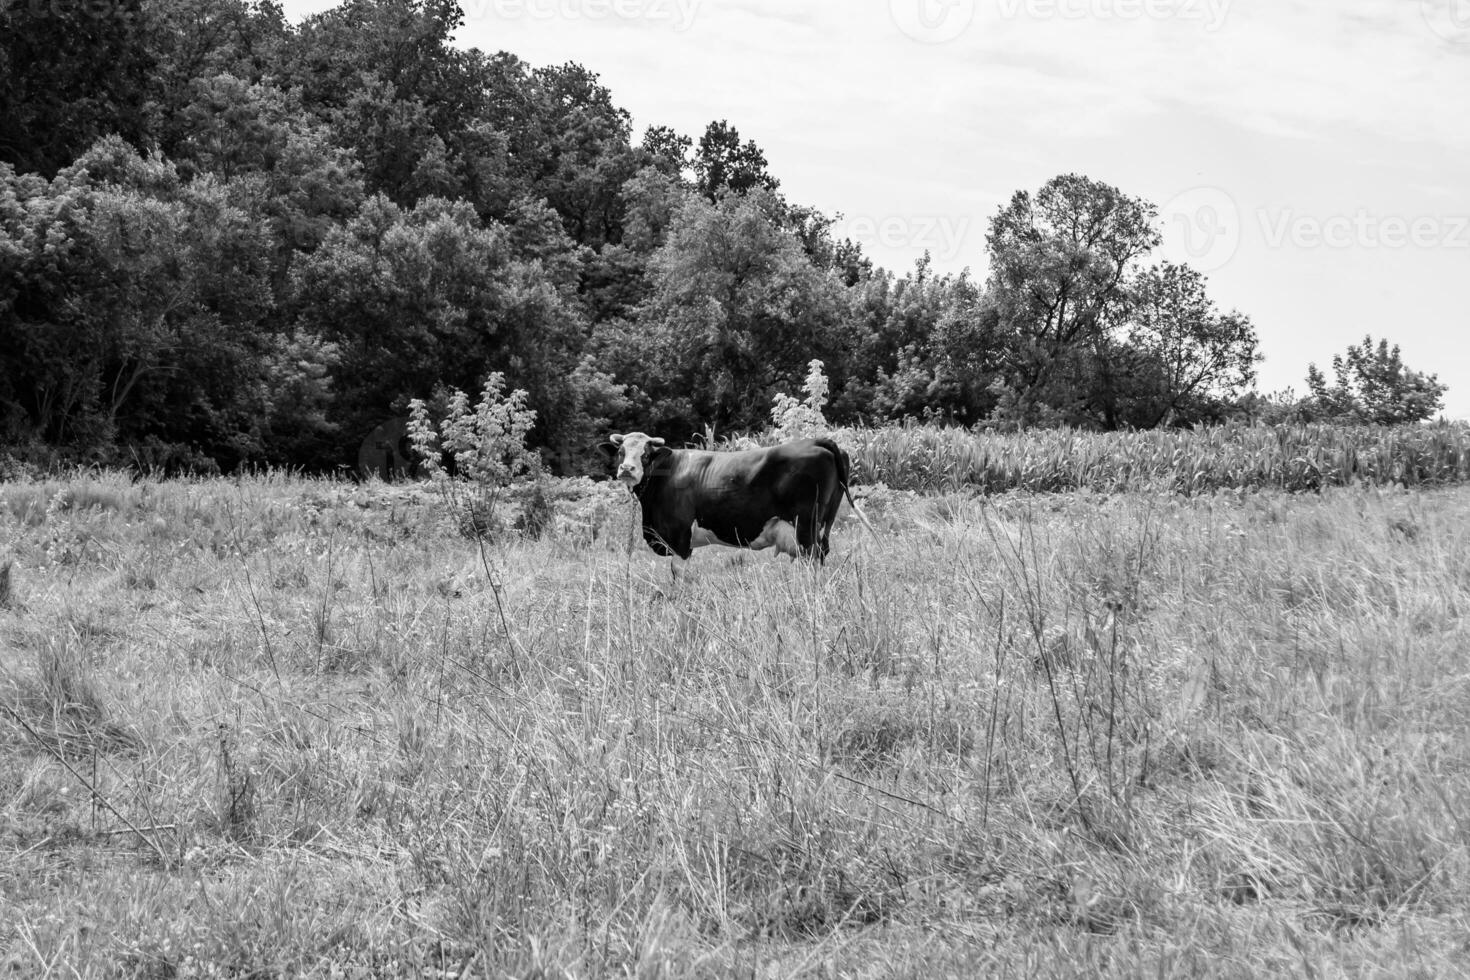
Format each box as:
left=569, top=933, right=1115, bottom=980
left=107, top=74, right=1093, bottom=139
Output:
left=0, top=476, right=1470, bottom=977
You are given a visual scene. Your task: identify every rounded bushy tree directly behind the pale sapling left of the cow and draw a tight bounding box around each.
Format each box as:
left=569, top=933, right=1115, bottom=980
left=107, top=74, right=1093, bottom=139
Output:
left=293, top=195, right=619, bottom=467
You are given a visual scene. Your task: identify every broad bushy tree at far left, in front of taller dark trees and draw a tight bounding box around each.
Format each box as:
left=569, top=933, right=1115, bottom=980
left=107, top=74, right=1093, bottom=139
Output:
left=0, top=138, right=316, bottom=464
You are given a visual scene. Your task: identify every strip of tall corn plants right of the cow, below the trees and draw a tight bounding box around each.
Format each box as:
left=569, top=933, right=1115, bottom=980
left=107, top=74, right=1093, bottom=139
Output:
left=832, top=423, right=1470, bottom=495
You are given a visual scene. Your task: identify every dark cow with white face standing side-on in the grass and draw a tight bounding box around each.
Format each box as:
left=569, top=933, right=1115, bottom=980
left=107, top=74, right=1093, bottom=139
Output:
left=612, top=432, right=851, bottom=561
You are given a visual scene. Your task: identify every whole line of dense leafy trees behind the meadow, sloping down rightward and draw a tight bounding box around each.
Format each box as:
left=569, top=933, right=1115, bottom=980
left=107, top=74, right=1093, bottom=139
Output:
left=0, top=0, right=1438, bottom=470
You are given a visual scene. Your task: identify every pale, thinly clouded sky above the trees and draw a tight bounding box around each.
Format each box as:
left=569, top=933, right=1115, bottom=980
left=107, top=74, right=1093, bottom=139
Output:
left=285, top=0, right=1470, bottom=417
